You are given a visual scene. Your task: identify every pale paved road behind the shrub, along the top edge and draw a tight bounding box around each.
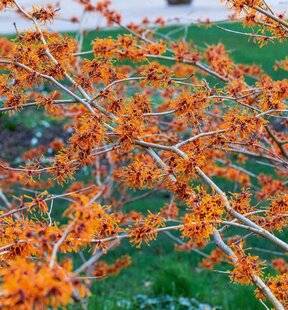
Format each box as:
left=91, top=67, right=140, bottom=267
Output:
left=0, top=0, right=288, bottom=33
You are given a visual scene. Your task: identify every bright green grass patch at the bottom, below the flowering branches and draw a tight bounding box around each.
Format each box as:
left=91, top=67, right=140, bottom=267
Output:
left=84, top=236, right=262, bottom=309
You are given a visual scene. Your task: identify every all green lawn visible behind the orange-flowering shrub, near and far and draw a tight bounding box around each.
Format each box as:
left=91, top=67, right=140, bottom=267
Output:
left=0, top=24, right=288, bottom=310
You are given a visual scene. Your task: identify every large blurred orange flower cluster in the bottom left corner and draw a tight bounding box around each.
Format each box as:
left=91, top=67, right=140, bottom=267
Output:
left=0, top=258, right=85, bottom=310
